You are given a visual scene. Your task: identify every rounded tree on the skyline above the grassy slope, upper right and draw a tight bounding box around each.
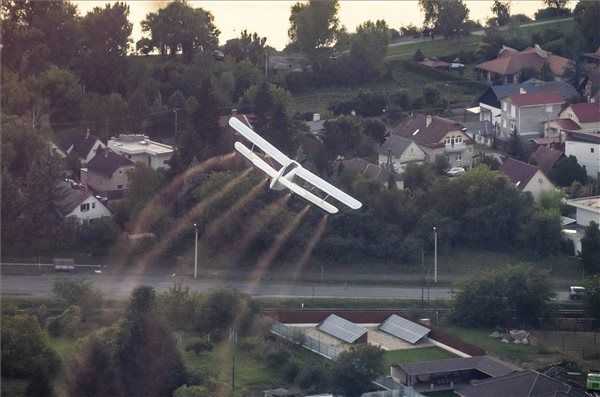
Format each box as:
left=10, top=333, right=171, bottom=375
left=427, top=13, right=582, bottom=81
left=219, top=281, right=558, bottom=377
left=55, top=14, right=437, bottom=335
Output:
left=419, top=0, right=469, bottom=37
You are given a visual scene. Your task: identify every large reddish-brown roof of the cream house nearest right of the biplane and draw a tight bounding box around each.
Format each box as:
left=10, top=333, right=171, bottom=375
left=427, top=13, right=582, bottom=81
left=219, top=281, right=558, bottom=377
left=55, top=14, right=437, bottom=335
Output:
left=392, top=114, right=468, bottom=147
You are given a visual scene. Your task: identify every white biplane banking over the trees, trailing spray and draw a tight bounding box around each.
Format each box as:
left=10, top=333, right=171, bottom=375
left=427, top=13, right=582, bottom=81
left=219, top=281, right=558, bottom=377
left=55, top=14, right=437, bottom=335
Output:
left=229, top=117, right=362, bottom=214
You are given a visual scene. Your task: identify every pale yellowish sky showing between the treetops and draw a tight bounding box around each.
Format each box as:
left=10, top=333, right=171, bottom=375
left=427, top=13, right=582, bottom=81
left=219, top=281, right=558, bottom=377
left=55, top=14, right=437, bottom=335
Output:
left=74, top=0, right=543, bottom=49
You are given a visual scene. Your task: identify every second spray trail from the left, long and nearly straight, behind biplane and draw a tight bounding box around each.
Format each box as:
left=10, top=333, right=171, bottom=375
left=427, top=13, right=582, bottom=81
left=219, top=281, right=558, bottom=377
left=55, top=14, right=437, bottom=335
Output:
left=131, top=168, right=252, bottom=272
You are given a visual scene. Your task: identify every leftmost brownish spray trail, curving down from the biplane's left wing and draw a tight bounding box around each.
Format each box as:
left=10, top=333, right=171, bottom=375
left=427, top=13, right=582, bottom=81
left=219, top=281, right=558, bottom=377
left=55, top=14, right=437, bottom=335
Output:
left=113, top=152, right=235, bottom=269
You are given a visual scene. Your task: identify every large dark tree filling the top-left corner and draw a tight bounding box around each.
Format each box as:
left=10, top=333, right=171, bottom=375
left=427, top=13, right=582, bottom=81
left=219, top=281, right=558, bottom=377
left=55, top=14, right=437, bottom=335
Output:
left=0, top=0, right=80, bottom=75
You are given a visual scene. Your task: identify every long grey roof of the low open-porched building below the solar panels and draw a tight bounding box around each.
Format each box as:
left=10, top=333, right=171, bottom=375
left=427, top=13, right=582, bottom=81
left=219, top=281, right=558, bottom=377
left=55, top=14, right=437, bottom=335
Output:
left=394, top=356, right=519, bottom=378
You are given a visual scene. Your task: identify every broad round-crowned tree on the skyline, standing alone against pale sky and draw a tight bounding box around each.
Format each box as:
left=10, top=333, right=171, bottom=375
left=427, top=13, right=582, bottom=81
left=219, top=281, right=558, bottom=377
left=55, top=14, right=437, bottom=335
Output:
left=137, top=0, right=220, bottom=62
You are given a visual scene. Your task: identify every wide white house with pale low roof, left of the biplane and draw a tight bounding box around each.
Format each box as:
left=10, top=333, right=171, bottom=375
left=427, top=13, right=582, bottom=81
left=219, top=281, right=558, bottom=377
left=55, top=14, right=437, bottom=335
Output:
left=108, top=134, right=175, bottom=170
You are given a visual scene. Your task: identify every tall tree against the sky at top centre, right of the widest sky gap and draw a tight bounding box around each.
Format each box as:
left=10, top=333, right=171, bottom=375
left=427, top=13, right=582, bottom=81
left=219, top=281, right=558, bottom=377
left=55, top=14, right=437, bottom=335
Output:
left=288, top=0, right=339, bottom=64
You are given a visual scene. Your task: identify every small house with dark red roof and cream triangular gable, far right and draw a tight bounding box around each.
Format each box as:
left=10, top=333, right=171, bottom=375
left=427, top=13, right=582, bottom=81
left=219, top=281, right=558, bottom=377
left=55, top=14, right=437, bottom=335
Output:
left=500, top=157, right=556, bottom=201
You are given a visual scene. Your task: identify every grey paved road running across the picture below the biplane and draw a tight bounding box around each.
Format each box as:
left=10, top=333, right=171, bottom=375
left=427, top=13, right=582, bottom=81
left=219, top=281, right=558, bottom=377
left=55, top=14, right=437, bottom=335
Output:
left=0, top=274, right=567, bottom=300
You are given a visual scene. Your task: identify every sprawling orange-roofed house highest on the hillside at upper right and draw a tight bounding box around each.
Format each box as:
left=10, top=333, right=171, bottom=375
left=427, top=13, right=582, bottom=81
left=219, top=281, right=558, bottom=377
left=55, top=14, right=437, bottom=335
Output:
left=476, top=44, right=572, bottom=84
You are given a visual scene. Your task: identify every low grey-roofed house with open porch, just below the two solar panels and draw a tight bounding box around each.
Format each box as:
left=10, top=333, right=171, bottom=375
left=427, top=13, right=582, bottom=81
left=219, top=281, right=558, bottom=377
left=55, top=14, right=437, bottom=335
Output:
left=390, top=356, right=519, bottom=390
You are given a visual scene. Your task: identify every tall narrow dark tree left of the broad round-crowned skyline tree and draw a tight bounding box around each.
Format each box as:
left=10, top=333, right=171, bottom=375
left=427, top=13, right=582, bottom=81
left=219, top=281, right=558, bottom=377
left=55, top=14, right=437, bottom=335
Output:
left=78, top=2, right=133, bottom=94
